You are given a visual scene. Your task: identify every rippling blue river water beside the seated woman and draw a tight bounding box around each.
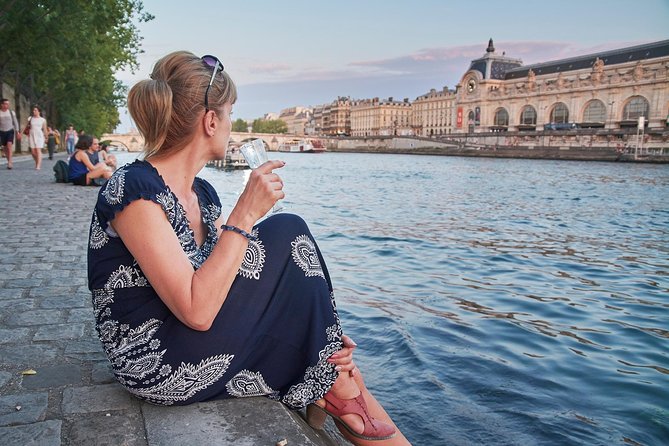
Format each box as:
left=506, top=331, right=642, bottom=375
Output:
left=112, top=153, right=669, bottom=445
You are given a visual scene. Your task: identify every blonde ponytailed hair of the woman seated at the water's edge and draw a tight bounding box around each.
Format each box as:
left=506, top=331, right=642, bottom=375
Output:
left=128, top=51, right=237, bottom=158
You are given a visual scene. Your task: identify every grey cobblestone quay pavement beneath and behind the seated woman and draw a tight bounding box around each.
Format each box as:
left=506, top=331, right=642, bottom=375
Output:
left=0, top=153, right=347, bottom=446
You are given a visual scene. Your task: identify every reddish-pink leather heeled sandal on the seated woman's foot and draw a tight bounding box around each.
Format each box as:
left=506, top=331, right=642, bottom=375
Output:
left=307, top=393, right=396, bottom=441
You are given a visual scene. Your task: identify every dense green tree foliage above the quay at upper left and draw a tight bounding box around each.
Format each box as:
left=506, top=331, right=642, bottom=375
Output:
left=0, top=0, right=153, bottom=134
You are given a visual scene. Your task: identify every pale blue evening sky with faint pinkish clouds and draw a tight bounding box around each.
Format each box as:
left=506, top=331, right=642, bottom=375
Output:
left=116, top=0, right=669, bottom=133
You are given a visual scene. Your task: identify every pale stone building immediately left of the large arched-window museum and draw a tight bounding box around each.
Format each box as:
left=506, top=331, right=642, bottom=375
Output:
left=411, top=87, right=455, bottom=137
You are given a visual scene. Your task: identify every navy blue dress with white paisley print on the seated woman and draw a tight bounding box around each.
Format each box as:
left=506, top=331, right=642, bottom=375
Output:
left=88, top=161, right=342, bottom=408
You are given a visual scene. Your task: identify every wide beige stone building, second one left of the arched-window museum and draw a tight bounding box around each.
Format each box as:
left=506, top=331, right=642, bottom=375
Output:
left=351, top=97, right=413, bottom=137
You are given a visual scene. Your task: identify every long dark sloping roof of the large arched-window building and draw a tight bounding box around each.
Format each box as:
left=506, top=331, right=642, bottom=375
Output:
left=504, top=40, right=669, bottom=80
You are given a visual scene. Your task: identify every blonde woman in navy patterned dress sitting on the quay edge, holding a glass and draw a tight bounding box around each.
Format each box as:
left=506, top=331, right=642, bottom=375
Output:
left=88, top=51, right=408, bottom=445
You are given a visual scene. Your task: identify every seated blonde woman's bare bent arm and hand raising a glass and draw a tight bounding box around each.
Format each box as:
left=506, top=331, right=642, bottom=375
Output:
left=112, top=161, right=283, bottom=331
